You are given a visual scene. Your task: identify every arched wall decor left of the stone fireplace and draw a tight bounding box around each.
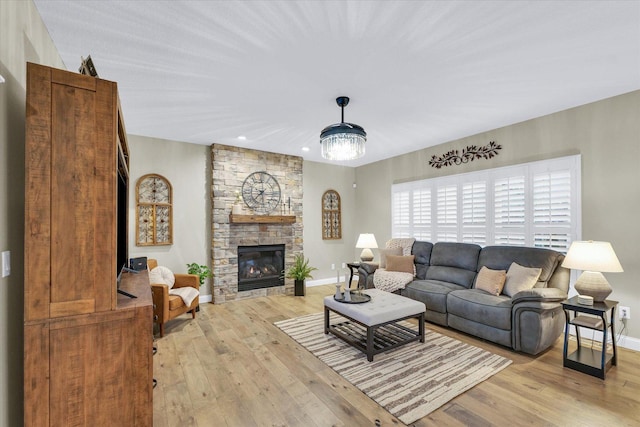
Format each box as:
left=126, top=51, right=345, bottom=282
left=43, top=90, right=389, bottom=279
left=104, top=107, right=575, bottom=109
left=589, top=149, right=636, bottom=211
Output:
left=136, top=174, right=173, bottom=246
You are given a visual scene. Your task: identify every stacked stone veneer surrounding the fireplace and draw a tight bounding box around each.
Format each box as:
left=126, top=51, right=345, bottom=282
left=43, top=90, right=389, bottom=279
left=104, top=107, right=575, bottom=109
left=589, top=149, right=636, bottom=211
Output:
left=211, top=144, right=302, bottom=304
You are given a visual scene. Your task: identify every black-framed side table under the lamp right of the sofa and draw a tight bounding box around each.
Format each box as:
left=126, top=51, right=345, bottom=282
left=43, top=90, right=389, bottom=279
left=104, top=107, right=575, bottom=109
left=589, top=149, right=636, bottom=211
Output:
left=562, top=296, right=618, bottom=380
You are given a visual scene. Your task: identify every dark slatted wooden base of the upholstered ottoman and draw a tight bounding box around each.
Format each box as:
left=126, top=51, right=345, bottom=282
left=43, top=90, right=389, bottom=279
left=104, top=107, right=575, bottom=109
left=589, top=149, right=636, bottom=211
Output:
left=324, top=306, right=424, bottom=362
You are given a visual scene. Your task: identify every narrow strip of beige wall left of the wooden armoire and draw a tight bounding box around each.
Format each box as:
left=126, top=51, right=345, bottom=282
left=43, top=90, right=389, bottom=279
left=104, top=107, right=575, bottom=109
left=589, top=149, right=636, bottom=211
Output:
left=0, top=1, right=65, bottom=426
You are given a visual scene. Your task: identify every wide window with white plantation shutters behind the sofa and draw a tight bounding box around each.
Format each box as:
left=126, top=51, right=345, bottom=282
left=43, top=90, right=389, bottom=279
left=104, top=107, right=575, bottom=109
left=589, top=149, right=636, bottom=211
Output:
left=391, top=156, right=580, bottom=252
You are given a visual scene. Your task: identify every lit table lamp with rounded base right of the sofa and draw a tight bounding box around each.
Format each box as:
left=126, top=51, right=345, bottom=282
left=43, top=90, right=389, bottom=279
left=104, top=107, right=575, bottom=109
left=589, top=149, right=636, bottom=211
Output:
left=562, top=240, right=624, bottom=302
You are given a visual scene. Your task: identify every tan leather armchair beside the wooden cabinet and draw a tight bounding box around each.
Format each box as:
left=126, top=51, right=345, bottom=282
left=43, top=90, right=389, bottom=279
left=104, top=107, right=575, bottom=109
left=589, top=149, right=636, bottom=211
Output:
left=147, top=259, right=200, bottom=337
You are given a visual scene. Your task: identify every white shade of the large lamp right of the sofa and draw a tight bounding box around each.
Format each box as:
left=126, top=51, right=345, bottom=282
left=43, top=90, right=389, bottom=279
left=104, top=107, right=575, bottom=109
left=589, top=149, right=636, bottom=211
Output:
left=562, top=240, right=624, bottom=273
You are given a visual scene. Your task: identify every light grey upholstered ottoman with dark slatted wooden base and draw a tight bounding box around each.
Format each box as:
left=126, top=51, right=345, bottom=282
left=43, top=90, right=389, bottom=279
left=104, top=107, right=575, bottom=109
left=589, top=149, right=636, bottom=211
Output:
left=324, top=289, right=426, bottom=362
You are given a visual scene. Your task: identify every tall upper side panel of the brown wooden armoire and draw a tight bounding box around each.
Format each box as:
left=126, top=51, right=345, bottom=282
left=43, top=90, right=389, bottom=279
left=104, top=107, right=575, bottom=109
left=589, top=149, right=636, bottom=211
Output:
left=25, top=64, right=117, bottom=320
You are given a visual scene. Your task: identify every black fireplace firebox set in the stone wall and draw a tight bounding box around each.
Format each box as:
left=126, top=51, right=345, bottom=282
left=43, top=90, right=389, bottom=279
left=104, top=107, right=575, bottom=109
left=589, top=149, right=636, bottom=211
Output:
left=238, top=245, right=284, bottom=292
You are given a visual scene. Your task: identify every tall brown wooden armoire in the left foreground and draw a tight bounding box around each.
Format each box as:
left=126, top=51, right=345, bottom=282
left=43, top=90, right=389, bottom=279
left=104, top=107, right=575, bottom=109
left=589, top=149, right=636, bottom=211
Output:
left=24, top=63, right=153, bottom=427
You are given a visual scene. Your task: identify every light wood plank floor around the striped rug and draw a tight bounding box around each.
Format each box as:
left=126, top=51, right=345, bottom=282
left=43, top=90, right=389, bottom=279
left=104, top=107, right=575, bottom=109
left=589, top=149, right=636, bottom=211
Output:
left=153, top=285, right=640, bottom=427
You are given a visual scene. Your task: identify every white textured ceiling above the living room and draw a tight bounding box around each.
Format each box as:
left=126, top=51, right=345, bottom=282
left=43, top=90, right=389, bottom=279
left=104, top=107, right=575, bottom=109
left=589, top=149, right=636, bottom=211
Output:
left=35, top=0, right=640, bottom=166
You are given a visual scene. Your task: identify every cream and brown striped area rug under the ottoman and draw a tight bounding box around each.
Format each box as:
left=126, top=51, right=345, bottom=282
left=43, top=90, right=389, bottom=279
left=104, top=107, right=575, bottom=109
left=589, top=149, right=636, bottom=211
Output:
left=275, top=313, right=511, bottom=424
